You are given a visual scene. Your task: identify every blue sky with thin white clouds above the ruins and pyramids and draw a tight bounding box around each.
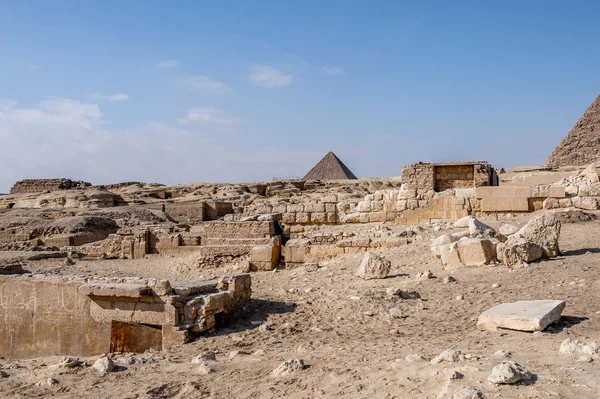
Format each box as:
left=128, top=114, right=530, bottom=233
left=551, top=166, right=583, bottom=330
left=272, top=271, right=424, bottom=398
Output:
left=0, top=0, right=600, bottom=192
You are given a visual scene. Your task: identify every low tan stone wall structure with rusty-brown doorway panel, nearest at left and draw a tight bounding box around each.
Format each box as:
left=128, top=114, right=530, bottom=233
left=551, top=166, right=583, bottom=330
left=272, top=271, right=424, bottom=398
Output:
left=0, top=274, right=252, bottom=358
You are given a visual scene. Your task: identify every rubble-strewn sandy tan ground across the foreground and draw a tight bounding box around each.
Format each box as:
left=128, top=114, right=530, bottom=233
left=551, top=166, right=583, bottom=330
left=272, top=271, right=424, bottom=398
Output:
left=0, top=213, right=600, bottom=399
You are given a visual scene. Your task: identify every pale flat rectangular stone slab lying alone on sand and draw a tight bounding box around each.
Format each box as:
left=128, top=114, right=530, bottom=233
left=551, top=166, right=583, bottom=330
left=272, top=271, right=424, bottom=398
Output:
left=477, top=300, right=565, bottom=331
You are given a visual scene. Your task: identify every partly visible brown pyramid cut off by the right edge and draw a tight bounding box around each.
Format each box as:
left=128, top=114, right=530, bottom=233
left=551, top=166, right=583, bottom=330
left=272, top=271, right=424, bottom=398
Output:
left=544, top=96, right=600, bottom=167
